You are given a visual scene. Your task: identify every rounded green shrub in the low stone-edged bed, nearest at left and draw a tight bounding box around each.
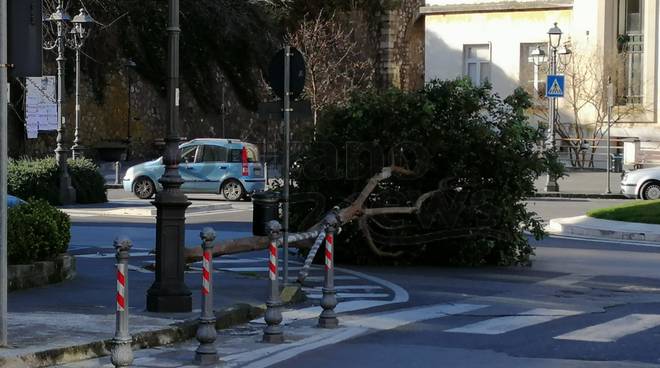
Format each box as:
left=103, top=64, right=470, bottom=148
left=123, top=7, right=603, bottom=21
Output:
left=7, top=199, right=71, bottom=264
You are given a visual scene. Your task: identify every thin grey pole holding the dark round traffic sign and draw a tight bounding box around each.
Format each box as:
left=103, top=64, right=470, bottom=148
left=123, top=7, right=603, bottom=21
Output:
left=282, top=45, right=291, bottom=286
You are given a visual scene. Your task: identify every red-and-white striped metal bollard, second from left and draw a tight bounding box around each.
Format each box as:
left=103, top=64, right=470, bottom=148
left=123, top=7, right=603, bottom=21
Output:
left=195, top=227, right=218, bottom=365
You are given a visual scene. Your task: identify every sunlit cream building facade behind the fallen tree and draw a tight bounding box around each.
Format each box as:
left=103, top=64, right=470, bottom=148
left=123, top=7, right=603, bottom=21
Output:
left=419, top=0, right=660, bottom=142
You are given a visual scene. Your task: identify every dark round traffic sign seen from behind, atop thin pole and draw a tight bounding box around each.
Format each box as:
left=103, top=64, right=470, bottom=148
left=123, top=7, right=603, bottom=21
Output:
left=268, top=47, right=306, bottom=99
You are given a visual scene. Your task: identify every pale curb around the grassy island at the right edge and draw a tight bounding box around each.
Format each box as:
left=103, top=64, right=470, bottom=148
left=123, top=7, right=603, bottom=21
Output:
left=546, top=216, right=660, bottom=242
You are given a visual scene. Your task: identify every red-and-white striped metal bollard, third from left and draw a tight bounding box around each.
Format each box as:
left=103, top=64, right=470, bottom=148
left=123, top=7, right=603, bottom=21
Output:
left=263, top=221, right=284, bottom=343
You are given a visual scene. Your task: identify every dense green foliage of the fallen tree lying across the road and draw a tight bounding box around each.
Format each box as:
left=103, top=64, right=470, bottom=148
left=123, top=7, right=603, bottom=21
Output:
left=293, top=80, right=549, bottom=265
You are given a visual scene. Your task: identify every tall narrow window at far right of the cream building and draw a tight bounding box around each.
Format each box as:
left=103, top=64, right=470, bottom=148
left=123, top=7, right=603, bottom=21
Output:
left=616, top=0, right=644, bottom=104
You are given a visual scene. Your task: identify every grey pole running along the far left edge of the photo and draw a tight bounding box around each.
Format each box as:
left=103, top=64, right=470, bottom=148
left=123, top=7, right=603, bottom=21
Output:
left=0, top=0, right=9, bottom=346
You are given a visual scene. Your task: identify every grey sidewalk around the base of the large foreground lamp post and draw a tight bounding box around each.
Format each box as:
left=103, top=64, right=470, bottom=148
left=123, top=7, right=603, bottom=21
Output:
left=0, top=251, right=302, bottom=367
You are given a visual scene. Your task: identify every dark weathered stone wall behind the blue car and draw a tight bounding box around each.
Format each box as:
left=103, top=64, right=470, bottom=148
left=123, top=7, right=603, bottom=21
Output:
left=10, top=61, right=264, bottom=159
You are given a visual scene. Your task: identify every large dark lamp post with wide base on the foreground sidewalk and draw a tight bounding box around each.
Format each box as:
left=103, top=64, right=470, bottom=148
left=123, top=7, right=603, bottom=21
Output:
left=147, top=0, right=192, bottom=312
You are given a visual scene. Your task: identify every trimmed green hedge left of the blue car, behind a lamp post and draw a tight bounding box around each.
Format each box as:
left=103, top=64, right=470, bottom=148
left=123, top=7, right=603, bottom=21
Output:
left=8, top=157, right=108, bottom=205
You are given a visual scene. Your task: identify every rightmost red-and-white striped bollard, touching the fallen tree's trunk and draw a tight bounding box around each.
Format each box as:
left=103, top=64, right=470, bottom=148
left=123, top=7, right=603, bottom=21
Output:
left=319, top=224, right=339, bottom=328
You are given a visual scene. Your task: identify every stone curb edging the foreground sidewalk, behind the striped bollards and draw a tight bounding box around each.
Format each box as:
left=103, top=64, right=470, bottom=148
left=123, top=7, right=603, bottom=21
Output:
left=0, top=304, right=266, bottom=368
